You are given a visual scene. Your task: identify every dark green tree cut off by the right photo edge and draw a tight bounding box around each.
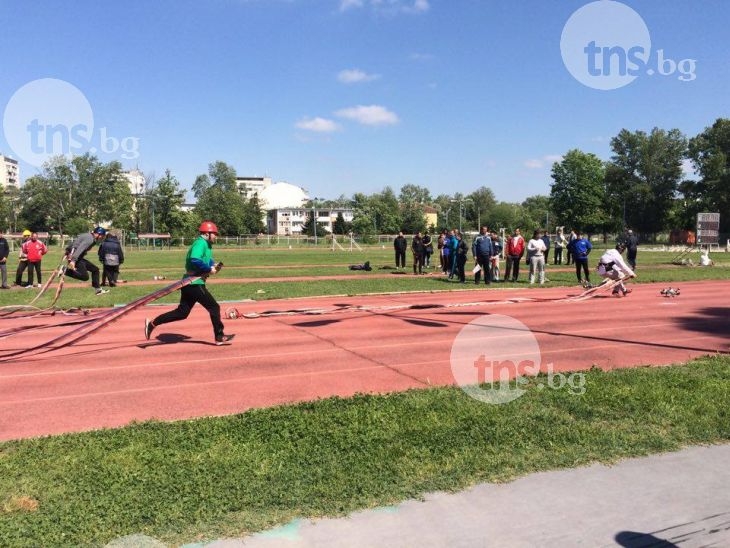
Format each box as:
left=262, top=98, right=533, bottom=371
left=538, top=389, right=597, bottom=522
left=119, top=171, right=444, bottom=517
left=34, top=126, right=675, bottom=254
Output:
left=681, top=118, right=730, bottom=232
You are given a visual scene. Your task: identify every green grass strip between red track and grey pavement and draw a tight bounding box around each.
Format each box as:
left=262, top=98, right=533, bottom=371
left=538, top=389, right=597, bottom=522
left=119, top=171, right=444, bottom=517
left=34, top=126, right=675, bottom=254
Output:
left=0, top=356, right=730, bottom=546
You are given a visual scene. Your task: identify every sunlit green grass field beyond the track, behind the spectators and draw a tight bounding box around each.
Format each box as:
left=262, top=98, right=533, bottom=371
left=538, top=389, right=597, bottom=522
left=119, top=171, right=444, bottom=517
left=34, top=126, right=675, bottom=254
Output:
left=0, top=244, right=730, bottom=308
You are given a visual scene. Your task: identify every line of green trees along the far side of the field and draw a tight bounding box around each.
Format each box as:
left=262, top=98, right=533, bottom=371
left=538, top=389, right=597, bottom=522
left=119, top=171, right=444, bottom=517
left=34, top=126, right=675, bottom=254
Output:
left=0, top=118, right=730, bottom=237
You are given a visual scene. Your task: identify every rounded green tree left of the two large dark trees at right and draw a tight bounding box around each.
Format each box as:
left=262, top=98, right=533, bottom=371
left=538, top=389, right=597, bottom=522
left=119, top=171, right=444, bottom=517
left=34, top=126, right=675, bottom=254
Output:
left=549, top=149, right=608, bottom=233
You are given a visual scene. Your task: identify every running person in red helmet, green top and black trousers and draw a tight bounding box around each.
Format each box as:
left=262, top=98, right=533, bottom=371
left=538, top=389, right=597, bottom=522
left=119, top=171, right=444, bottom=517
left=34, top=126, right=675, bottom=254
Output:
left=144, top=221, right=235, bottom=346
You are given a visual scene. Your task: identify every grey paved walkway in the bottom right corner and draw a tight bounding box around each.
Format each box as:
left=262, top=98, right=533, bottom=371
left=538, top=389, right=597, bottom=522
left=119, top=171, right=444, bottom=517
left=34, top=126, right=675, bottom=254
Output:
left=205, top=445, right=730, bottom=548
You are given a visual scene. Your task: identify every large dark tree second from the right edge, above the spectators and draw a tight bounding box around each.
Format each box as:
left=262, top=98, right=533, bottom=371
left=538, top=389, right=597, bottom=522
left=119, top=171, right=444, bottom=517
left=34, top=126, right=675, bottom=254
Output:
left=606, top=128, right=687, bottom=239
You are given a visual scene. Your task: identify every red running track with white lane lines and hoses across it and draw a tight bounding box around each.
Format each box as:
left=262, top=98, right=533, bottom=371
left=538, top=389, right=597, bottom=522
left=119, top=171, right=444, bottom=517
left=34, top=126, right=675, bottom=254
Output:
left=0, top=281, right=730, bottom=440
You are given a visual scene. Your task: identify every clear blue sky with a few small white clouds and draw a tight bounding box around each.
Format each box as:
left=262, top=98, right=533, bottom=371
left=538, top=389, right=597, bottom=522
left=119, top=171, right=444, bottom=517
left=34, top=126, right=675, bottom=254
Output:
left=0, top=0, right=730, bottom=201
